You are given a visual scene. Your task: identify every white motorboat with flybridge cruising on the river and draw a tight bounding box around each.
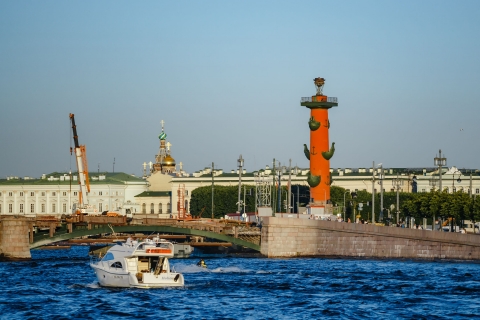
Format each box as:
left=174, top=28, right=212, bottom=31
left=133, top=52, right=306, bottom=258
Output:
left=90, top=238, right=184, bottom=288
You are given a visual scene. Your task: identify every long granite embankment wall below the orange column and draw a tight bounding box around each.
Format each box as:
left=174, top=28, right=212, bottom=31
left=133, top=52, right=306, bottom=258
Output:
left=261, top=217, right=480, bottom=260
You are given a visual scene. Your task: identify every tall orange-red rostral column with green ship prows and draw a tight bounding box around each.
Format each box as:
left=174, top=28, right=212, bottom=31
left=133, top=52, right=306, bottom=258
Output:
left=300, top=78, right=338, bottom=215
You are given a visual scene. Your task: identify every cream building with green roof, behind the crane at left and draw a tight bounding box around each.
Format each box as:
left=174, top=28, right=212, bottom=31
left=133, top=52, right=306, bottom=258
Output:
left=0, top=173, right=147, bottom=216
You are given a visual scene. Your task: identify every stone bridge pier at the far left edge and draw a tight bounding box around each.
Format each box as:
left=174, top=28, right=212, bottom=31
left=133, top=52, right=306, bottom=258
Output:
left=0, top=216, right=32, bottom=261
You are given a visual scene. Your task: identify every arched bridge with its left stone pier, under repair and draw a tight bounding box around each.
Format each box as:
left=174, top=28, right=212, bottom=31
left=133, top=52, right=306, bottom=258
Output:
left=0, top=215, right=261, bottom=261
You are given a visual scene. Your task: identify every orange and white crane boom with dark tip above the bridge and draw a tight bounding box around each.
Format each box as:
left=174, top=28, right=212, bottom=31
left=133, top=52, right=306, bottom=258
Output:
left=70, top=113, right=90, bottom=213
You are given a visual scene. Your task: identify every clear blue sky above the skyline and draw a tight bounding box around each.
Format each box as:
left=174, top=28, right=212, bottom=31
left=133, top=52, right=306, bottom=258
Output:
left=0, top=0, right=480, bottom=178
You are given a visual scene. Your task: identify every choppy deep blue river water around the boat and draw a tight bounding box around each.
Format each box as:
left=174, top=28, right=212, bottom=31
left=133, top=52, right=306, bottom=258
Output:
left=0, top=246, right=480, bottom=319
